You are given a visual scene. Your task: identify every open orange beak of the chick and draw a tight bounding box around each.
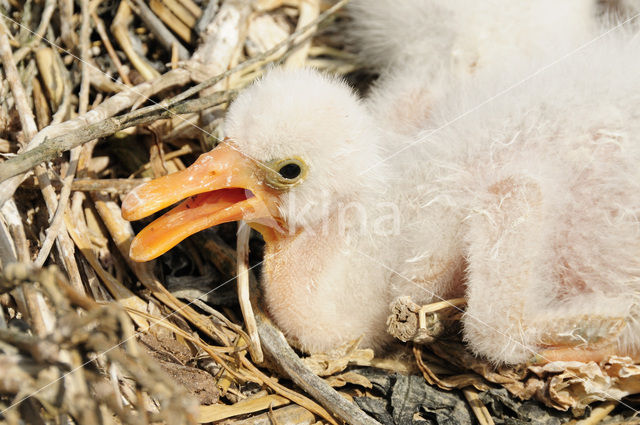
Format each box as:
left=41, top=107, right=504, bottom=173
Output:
left=122, top=143, right=278, bottom=261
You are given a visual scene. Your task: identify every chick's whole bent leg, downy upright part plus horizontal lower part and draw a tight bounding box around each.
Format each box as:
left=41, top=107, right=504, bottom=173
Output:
left=463, top=176, right=629, bottom=363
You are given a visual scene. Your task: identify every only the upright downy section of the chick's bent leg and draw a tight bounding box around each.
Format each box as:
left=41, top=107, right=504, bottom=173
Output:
left=463, top=176, right=548, bottom=363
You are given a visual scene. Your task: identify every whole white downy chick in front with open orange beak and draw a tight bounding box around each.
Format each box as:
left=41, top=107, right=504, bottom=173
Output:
left=123, top=2, right=640, bottom=363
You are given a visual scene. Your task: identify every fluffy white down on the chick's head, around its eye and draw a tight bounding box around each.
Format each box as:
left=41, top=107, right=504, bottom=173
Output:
left=225, top=68, right=386, bottom=227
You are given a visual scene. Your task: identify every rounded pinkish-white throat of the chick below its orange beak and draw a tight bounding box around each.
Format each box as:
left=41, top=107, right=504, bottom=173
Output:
left=262, top=205, right=389, bottom=352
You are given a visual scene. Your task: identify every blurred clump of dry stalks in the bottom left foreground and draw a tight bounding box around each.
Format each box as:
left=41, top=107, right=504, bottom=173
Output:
left=0, top=263, right=196, bottom=424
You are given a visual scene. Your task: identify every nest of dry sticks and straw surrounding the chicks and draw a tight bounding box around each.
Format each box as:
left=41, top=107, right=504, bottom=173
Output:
left=0, top=0, right=638, bottom=424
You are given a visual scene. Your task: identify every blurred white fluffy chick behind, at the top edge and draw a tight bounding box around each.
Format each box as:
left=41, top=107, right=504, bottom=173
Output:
left=349, top=0, right=596, bottom=73
